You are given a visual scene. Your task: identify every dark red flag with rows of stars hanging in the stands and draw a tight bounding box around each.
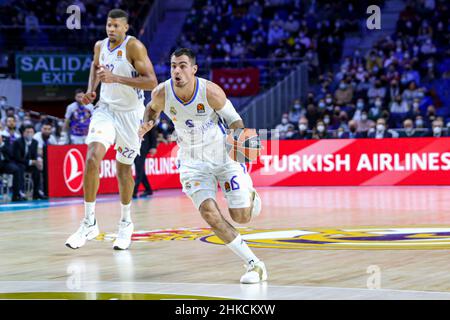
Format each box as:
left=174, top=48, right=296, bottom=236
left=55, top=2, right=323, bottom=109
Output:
left=212, top=68, right=259, bottom=97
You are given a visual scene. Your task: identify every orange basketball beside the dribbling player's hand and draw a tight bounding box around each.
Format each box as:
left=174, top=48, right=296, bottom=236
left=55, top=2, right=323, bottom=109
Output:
left=226, top=128, right=261, bottom=163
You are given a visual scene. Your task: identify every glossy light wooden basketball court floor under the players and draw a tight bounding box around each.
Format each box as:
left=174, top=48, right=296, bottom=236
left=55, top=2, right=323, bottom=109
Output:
left=0, top=187, right=450, bottom=299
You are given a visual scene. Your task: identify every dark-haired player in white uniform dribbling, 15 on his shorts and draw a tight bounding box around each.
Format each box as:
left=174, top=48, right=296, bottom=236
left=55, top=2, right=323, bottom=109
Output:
left=139, top=48, right=267, bottom=283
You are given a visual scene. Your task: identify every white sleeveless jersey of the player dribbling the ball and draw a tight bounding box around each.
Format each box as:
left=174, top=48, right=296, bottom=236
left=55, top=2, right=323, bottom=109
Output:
left=164, top=77, right=229, bottom=163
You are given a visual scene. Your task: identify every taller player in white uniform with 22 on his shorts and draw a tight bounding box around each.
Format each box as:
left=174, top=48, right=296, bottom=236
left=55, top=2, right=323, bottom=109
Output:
left=66, top=9, right=158, bottom=250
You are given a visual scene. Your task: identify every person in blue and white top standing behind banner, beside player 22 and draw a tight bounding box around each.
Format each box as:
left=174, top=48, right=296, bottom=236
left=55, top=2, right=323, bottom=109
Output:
left=64, top=89, right=94, bottom=144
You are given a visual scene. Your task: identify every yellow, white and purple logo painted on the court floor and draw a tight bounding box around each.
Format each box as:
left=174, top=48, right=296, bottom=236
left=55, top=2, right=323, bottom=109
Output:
left=97, top=227, right=450, bottom=250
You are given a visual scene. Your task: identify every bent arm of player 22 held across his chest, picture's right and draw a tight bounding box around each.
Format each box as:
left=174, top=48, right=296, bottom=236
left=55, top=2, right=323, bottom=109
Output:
left=98, top=39, right=158, bottom=90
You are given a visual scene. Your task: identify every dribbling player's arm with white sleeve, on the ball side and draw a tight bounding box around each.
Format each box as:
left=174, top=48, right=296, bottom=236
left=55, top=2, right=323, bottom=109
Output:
left=206, top=81, right=245, bottom=129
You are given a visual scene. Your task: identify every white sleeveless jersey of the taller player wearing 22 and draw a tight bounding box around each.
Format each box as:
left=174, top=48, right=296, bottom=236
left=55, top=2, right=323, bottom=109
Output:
left=98, top=36, right=144, bottom=111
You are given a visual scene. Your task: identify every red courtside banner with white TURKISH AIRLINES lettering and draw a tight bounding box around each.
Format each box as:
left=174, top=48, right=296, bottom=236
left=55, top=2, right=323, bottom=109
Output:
left=48, top=138, right=450, bottom=197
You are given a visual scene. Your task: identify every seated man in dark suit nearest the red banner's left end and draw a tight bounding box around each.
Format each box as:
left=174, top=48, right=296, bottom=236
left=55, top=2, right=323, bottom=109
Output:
left=13, top=125, right=46, bottom=200
